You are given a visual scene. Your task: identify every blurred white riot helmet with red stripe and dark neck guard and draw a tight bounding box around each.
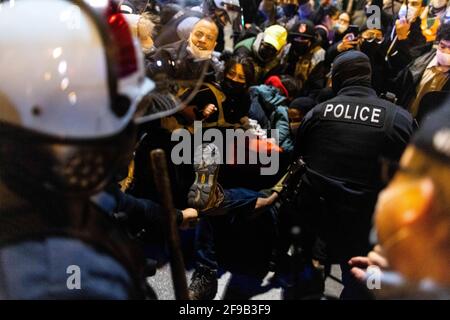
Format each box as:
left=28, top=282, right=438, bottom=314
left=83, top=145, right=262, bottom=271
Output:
left=0, top=0, right=153, bottom=195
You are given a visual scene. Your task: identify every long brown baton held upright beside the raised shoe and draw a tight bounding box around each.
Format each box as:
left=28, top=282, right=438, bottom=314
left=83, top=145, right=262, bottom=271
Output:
left=150, top=149, right=189, bottom=300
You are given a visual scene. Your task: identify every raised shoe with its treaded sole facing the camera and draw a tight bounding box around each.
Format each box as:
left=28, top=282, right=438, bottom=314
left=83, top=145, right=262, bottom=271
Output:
left=187, top=143, right=224, bottom=212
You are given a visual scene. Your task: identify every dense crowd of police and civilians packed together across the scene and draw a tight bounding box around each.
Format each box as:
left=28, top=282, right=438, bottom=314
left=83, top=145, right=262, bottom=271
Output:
left=0, top=0, right=450, bottom=300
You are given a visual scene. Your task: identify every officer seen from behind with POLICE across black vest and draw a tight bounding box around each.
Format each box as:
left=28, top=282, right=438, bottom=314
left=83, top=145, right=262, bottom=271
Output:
left=295, top=51, right=413, bottom=298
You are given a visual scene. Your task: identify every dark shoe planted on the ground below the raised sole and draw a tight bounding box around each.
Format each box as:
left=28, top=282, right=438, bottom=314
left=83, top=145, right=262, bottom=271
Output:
left=188, top=266, right=217, bottom=300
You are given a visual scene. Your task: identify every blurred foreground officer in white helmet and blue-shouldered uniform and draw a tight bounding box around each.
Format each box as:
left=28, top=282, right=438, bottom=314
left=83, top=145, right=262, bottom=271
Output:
left=0, top=0, right=153, bottom=299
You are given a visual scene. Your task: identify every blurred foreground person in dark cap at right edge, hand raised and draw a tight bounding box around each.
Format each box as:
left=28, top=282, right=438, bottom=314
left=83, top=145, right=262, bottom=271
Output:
left=349, top=104, right=450, bottom=299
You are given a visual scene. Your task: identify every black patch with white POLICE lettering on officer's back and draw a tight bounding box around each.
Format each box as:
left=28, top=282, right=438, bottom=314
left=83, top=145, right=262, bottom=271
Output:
left=320, top=103, right=386, bottom=128
